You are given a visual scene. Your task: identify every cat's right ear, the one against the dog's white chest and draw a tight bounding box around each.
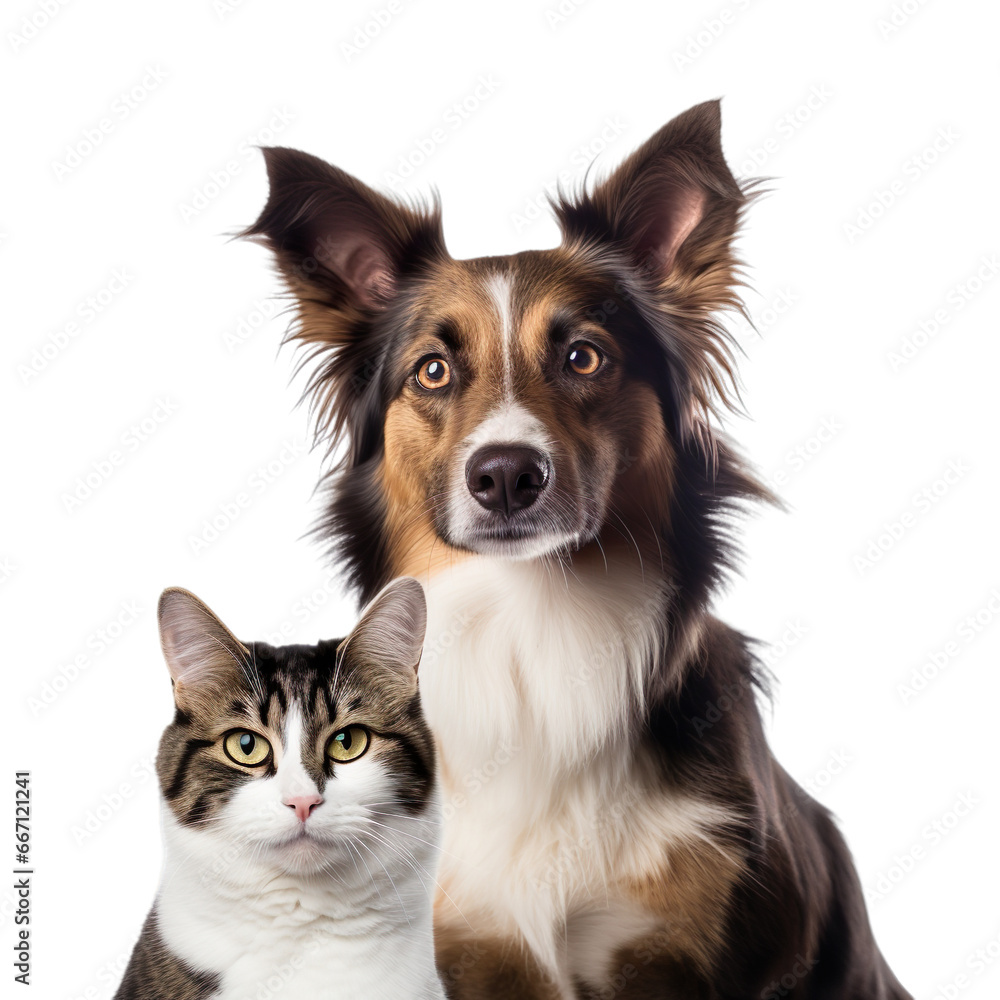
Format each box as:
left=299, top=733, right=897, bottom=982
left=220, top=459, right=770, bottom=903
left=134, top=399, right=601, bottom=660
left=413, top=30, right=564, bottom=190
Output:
left=342, top=576, right=427, bottom=684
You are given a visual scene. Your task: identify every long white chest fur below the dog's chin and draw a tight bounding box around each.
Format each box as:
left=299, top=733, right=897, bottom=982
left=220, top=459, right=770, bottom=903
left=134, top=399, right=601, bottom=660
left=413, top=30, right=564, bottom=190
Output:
left=420, top=557, right=722, bottom=982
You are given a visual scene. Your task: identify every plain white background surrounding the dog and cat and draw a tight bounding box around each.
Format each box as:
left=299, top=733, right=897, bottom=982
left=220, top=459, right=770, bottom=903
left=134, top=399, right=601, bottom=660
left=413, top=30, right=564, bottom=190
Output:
left=0, top=0, right=1000, bottom=1000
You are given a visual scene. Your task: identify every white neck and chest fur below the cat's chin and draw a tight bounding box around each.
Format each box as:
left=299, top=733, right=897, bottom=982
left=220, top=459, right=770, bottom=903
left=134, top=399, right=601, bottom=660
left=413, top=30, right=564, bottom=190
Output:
left=156, top=815, right=444, bottom=1000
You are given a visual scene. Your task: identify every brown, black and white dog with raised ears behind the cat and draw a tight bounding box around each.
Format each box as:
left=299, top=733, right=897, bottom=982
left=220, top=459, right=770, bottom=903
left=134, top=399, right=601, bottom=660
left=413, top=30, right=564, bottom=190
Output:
left=245, top=102, right=908, bottom=1000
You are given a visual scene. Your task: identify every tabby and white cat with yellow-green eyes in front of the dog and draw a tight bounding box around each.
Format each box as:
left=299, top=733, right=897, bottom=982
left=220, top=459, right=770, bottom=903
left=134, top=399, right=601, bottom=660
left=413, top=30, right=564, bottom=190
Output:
left=115, top=578, right=444, bottom=1000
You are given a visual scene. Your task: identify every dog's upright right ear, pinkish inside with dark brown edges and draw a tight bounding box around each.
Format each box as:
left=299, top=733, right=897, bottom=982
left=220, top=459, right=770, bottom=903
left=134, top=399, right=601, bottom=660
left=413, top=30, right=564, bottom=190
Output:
left=553, top=101, right=746, bottom=311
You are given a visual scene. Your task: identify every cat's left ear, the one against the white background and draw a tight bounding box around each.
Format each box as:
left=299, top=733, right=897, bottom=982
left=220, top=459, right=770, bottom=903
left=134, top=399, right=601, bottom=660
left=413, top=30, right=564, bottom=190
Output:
left=157, top=587, right=250, bottom=711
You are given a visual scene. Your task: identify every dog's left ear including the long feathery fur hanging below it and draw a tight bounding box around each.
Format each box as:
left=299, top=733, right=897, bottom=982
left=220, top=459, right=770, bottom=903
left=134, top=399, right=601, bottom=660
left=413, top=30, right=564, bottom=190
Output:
left=240, top=147, right=447, bottom=463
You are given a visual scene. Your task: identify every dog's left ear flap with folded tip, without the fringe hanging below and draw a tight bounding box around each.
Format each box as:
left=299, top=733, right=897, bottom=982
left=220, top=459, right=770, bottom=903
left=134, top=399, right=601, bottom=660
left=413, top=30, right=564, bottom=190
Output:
left=240, top=146, right=445, bottom=324
